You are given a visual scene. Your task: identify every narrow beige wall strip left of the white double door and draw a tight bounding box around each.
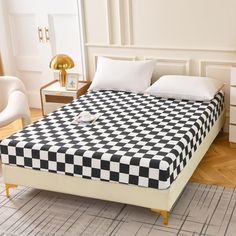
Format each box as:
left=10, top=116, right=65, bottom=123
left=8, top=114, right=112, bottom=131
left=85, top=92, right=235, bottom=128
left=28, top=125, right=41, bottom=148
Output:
left=0, top=0, right=15, bottom=75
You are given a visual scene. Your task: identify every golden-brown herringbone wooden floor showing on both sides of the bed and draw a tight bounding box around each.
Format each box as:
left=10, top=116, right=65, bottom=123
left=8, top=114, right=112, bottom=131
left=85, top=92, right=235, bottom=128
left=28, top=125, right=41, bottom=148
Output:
left=0, top=109, right=236, bottom=187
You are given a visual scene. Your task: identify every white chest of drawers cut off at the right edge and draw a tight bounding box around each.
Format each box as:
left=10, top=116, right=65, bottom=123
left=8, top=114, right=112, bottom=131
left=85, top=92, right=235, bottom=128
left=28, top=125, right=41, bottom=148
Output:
left=229, top=67, right=236, bottom=147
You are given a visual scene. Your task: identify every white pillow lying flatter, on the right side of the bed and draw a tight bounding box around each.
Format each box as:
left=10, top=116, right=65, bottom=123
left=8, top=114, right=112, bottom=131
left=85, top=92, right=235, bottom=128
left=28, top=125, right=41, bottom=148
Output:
left=145, top=75, right=224, bottom=101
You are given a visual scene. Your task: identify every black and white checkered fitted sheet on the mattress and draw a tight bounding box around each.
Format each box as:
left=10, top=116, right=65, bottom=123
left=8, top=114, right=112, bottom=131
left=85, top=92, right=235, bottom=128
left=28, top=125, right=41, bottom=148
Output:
left=0, top=91, right=224, bottom=189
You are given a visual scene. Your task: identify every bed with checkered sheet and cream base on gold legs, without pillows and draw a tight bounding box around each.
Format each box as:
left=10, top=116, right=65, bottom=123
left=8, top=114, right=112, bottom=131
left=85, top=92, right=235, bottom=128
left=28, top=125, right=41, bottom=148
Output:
left=0, top=91, right=225, bottom=224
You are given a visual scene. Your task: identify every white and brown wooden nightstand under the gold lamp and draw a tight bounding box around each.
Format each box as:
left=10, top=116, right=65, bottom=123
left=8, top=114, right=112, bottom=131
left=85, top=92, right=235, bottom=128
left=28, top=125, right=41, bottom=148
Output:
left=40, top=80, right=91, bottom=115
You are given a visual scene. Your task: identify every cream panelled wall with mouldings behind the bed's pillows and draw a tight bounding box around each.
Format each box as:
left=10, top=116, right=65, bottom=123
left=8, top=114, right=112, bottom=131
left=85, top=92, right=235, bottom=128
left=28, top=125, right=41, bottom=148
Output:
left=81, top=0, right=236, bottom=131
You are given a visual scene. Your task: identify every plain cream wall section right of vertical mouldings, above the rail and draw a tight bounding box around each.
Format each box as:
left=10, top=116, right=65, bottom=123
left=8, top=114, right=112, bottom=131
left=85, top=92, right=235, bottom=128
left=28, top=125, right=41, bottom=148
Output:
left=130, top=0, right=236, bottom=49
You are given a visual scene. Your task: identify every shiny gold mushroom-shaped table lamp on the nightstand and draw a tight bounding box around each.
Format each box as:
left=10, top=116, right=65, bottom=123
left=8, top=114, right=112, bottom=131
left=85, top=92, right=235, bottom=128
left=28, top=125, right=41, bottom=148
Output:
left=49, top=54, right=74, bottom=87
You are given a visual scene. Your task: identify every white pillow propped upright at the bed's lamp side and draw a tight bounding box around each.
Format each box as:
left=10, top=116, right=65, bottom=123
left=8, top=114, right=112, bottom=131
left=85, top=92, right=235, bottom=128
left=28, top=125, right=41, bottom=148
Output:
left=89, top=57, right=155, bottom=93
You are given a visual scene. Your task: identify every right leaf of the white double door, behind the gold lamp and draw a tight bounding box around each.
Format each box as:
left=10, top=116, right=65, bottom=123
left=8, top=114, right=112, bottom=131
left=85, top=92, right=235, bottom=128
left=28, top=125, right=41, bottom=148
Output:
left=43, top=0, right=83, bottom=74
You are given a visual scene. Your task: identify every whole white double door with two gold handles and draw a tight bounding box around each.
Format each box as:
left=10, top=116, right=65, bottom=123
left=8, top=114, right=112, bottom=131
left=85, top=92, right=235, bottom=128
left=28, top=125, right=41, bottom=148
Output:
left=6, top=0, right=83, bottom=107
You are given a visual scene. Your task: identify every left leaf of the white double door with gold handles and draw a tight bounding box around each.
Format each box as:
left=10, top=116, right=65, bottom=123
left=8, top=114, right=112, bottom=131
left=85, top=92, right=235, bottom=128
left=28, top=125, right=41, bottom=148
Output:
left=7, top=0, right=53, bottom=107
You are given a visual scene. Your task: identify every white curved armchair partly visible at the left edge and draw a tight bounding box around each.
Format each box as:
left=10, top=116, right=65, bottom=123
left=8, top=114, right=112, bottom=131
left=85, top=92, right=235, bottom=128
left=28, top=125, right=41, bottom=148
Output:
left=0, top=76, right=31, bottom=127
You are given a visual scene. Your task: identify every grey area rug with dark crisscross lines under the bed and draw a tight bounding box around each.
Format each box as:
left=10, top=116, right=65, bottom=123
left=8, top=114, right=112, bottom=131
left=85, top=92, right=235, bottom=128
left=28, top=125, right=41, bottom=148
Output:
left=0, top=175, right=236, bottom=236
